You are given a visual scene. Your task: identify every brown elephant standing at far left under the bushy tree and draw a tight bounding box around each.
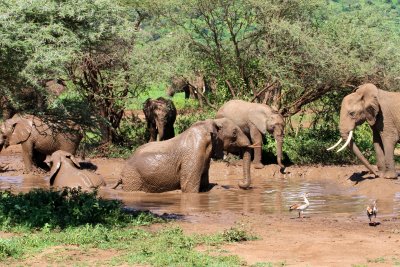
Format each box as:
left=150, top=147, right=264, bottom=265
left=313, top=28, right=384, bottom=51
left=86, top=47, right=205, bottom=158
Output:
left=0, top=114, right=83, bottom=173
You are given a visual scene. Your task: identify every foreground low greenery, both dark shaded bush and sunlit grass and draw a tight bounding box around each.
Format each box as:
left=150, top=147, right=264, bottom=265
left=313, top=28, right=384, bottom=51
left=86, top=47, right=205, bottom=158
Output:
left=0, top=189, right=262, bottom=266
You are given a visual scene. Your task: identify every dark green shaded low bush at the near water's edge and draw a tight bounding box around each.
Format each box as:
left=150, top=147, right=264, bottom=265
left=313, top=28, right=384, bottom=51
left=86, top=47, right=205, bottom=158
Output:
left=0, top=188, right=162, bottom=229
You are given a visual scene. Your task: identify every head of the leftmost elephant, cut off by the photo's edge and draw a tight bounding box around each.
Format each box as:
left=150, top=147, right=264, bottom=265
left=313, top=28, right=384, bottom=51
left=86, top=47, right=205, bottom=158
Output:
left=0, top=114, right=33, bottom=151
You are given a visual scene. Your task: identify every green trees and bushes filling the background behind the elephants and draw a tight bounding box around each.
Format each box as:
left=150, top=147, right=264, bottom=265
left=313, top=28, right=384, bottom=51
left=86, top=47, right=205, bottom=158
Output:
left=0, top=0, right=400, bottom=163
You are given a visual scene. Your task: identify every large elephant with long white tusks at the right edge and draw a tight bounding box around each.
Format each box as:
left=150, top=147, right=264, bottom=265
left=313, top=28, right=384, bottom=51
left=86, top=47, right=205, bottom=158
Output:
left=328, top=83, right=400, bottom=178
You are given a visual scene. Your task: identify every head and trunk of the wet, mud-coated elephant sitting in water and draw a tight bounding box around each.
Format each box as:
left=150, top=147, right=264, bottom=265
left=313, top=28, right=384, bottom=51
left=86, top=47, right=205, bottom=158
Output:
left=213, top=118, right=257, bottom=189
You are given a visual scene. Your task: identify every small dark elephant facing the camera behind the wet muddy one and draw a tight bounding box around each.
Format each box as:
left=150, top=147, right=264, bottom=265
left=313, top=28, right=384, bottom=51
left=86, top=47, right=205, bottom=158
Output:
left=143, top=97, right=176, bottom=142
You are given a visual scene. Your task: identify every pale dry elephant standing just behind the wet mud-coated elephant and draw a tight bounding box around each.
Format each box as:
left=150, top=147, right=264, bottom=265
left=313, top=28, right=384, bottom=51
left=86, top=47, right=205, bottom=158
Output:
left=216, top=100, right=285, bottom=170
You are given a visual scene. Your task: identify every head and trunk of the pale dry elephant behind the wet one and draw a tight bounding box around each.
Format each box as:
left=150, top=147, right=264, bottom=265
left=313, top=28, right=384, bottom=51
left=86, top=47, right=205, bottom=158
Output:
left=249, top=108, right=285, bottom=168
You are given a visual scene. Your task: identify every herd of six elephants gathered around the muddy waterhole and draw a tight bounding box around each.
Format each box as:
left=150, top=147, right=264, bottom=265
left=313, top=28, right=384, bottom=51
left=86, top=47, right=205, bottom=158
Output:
left=0, top=84, right=400, bottom=192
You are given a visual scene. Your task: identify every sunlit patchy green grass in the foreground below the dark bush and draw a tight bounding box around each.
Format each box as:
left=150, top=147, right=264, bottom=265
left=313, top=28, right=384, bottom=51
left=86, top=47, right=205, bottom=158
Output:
left=0, top=225, right=256, bottom=266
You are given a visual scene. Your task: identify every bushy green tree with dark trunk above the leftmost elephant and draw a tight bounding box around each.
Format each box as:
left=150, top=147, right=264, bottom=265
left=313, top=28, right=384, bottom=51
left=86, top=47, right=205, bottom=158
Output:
left=0, top=0, right=148, bottom=142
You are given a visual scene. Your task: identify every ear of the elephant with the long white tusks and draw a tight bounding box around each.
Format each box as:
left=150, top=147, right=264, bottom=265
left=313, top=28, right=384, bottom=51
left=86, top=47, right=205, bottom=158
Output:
left=356, top=83, right=379, bottom=126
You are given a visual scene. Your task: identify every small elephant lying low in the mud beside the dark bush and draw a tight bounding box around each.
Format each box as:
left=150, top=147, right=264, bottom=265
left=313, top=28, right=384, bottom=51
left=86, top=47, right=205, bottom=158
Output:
left=50, top=150, right=106, bottom=190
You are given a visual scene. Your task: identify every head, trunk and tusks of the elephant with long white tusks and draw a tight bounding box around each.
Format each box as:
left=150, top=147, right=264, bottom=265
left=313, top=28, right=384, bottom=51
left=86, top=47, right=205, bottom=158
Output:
left=328, top=83, right=380, bottom=175
